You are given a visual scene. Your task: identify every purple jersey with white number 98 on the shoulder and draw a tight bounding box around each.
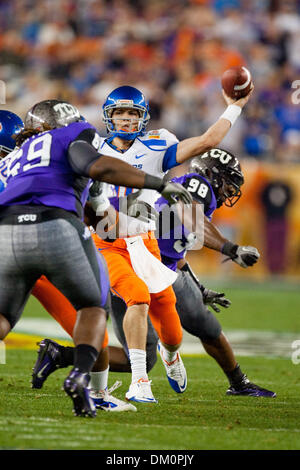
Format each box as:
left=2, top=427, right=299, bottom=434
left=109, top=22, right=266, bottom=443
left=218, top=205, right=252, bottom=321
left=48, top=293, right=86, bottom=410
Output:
left=155, top=173, right=217, bottom=271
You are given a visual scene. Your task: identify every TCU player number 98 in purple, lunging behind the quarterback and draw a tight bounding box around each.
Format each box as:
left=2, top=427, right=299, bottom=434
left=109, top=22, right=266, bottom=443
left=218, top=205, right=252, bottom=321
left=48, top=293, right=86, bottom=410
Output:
left=110, top=149, right=276, bottom=398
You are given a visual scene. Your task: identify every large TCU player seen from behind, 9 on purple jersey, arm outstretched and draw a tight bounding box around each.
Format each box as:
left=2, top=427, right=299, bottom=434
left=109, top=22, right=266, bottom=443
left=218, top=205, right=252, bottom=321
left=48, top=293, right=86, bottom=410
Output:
left=0, top=100, right=191, bottom=417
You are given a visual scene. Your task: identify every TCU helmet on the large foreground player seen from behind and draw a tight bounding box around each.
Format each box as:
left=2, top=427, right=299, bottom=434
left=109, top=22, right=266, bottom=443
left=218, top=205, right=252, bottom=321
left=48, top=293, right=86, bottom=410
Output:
left=25, top=100, right=82, bottom=131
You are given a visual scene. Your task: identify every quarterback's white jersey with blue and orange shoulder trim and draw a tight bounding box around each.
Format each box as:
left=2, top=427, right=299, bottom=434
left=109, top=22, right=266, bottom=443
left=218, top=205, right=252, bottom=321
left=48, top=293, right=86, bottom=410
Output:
left=98, top=129, right=179, bottom=236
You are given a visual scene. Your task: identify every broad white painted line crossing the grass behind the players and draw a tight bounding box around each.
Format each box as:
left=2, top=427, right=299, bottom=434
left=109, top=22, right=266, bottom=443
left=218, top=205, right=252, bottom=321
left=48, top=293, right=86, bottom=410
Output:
left=13, top=318, right=300, bottom=358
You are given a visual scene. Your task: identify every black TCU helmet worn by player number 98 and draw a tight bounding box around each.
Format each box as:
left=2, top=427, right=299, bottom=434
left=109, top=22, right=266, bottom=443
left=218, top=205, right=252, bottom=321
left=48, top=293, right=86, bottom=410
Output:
left=190, top=148, right=244, bottom=207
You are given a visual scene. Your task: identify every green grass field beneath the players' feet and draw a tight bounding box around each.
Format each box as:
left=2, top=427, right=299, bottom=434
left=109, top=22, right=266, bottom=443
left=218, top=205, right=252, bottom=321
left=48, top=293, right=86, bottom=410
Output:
left=0, top=280, right=300, bottom=450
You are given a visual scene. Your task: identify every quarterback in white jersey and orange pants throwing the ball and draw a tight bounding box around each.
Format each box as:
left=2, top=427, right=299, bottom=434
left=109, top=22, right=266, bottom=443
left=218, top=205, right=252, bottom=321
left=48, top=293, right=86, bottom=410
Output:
left=30, top=86, right=253, bottom=403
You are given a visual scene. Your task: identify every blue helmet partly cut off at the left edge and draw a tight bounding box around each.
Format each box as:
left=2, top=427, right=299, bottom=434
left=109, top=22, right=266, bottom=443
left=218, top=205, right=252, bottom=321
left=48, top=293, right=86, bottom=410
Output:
left=0, top=109, right=24, bottom=154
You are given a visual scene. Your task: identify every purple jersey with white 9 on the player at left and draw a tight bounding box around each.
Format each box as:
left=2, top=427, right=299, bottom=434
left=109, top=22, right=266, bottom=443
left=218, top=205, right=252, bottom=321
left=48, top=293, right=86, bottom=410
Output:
left=0, top=122, right=95, bottom=217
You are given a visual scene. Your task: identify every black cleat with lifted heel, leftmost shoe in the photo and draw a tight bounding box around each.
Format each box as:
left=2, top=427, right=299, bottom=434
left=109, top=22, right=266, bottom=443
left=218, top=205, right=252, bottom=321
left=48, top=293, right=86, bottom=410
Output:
left=31, top=339, right=62, bottom=388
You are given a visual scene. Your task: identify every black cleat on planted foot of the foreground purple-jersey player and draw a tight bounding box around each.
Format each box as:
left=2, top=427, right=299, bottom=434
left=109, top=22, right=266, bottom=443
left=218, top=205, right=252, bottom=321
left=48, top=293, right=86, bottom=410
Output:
left=63, top=369, right=97, bottom=418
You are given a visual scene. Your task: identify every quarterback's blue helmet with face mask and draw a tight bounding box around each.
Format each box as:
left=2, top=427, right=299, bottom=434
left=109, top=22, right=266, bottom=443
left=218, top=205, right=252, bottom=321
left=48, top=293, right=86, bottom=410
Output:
left=103, top=86, right=150, bottom=140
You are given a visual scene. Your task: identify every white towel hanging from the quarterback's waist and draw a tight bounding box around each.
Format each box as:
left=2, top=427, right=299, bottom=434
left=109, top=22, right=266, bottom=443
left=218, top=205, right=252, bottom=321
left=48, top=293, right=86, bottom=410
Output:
left=124, top=236, right=177, bottom=294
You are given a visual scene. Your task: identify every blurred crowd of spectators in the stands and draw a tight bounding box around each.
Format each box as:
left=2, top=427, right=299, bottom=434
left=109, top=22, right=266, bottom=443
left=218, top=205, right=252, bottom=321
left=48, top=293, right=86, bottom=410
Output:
left=0, top=0, right=300, bottom=162
